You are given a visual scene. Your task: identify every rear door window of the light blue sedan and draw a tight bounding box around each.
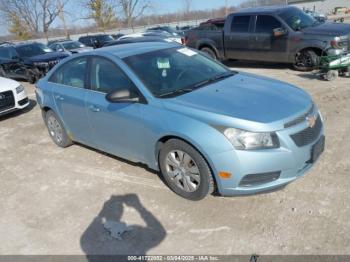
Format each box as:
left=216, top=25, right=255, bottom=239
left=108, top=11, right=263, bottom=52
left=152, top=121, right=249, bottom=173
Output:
left=49, top=57, right=87, bottom=88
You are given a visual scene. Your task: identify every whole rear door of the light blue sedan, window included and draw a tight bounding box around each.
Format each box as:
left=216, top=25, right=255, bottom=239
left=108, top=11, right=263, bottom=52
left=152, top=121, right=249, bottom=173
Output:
left=49, top=57, right=93, bottom=146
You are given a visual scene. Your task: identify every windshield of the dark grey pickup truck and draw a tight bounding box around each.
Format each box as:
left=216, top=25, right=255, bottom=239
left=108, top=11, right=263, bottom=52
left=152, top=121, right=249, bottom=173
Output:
left=280, top=8, right=319, bottom=31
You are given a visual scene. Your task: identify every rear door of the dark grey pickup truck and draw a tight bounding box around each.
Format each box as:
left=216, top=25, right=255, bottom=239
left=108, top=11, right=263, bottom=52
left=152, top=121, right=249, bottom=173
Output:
left=224, top=15, right=252, bottom=59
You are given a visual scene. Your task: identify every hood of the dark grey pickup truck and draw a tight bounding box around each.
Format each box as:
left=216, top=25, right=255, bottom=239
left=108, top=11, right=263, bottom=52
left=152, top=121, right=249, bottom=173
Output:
left=303, top=22, right=350, bottom=36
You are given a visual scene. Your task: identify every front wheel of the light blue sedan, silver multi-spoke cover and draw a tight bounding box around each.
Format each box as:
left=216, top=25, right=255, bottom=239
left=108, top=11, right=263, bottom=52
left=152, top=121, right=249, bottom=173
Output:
left=159, top=139, right=215, bottom=201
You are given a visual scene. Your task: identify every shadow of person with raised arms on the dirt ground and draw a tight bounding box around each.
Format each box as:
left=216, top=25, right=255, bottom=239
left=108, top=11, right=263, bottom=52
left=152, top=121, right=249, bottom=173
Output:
left=80, top=194, right=166, bottom=262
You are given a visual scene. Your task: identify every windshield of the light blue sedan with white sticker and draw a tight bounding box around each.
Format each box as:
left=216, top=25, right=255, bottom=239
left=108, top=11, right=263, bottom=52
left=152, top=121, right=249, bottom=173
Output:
left=124, top=47, right=233, bottom=98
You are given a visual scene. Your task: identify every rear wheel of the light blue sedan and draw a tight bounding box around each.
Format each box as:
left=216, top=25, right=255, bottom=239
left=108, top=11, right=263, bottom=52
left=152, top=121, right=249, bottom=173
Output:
left=45, top=110, right=73, bottom=148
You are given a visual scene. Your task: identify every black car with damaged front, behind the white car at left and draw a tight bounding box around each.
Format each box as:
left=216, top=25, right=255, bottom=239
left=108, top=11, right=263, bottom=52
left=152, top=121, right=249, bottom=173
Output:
left=0, top=42, right=69, bottom=83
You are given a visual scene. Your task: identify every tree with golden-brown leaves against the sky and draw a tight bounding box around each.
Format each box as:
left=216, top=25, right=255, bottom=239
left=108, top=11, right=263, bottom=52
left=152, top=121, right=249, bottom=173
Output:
left=85, top=0, right=116, bottom=29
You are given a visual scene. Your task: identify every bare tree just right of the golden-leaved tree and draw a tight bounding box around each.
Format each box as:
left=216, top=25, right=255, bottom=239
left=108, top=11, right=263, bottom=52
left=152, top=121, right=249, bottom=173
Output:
left=119, top=0, right=151, bottom=27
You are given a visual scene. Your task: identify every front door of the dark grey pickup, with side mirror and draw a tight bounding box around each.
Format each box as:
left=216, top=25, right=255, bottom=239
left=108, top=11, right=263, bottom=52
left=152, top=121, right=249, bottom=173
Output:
left=251, top=15, right=288, bottom=62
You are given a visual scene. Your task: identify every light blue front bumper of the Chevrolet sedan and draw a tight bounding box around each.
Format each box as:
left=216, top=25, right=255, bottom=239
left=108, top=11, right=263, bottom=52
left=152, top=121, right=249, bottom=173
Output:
left=210, top=116, right=324, bottom=196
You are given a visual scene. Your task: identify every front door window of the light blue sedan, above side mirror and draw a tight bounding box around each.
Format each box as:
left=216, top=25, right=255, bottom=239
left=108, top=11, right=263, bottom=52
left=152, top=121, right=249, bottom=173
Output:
left=91, top=58, right=136, bottom=95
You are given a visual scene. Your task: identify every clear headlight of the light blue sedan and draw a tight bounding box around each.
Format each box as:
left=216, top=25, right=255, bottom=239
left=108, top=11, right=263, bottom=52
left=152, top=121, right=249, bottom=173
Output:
left=223, top=128, right=280, bottom=150
